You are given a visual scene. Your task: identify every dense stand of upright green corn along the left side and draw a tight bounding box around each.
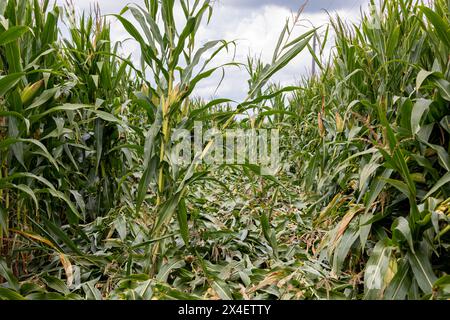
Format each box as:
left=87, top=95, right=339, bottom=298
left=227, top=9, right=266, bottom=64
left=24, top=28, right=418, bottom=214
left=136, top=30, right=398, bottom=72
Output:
left=0, top=1, right=138, bottom=292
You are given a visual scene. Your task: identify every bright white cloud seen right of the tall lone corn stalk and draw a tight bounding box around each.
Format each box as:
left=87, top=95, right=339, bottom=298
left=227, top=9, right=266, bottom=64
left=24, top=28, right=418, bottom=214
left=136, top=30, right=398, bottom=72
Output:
left=192, top=4, right=359, bottom=100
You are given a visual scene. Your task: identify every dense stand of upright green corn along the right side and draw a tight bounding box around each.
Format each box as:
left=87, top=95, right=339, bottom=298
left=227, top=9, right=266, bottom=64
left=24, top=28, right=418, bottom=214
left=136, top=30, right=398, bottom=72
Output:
left=276, top=1, right=448, bottom=299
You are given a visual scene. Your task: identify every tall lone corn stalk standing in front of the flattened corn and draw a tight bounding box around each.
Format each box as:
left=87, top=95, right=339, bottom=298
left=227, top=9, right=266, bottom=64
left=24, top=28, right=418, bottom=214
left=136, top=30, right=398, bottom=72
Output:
left=116, top=0, right=312, bottom=276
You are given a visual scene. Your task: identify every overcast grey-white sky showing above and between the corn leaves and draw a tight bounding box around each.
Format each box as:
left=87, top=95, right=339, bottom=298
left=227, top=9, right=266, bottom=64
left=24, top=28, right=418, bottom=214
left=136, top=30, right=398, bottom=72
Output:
left=57, top=0, right=368, bottom=100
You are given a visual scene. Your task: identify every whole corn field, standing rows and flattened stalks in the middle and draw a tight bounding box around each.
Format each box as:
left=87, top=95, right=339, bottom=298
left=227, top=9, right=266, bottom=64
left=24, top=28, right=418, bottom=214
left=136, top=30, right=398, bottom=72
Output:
left=0, top=0, right=450, bottom=300
